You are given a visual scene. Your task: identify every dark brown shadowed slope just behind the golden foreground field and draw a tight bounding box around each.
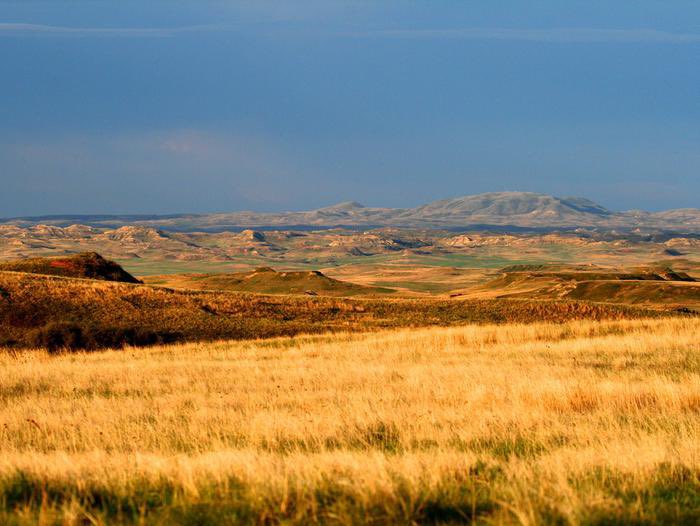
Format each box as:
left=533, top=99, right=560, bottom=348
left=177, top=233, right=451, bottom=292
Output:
left=0, top=272, right=663, bottom=349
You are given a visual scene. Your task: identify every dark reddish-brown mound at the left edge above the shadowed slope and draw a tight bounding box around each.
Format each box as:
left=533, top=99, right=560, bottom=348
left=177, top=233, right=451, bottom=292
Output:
left=0, top=252, right=141, bottom=283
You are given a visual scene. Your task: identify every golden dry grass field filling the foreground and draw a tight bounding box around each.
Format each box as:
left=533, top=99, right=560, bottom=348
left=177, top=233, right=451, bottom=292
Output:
left=0, top=318, right=700, bottom=524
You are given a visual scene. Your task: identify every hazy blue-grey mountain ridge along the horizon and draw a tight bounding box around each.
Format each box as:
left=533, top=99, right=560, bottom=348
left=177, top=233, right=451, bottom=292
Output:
left=4, top=192, right=700, bottom=232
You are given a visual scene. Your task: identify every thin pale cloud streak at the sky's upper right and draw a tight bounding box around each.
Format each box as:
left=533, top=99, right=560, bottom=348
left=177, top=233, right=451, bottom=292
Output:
left=346, top=27, right=700, bottom=44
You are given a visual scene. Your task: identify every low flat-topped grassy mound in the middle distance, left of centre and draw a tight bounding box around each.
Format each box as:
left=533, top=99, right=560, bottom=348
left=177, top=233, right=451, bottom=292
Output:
left=144, top=267, right=395, bottom=297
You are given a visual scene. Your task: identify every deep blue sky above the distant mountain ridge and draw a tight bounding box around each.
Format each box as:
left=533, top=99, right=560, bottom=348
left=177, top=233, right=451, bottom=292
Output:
left=0, top=0, right=700, bottom=217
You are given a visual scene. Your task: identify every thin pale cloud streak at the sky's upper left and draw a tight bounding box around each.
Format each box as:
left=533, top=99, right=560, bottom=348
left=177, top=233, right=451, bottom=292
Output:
left=0, top=23, right=227, bottom=37
